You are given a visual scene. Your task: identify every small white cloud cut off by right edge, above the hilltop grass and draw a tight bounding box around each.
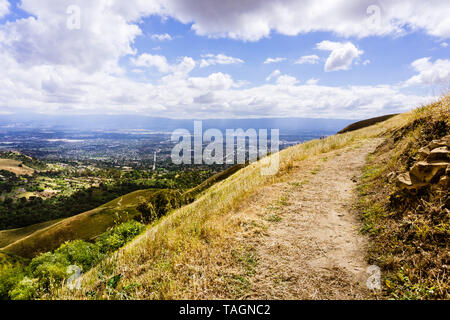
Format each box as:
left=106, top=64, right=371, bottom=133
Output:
left=406, top=57, right=450, bottom=86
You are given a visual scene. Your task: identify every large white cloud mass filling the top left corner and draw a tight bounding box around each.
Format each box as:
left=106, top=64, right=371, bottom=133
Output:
left=0, top=0, right=163, bottom=72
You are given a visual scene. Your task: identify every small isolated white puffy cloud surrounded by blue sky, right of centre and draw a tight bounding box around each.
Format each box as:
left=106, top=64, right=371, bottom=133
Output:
left=317, top=40, right=364, bottom=72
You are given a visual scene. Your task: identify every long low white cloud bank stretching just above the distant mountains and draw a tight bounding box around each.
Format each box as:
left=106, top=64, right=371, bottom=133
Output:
left=0, top=47, right=430, bottom=118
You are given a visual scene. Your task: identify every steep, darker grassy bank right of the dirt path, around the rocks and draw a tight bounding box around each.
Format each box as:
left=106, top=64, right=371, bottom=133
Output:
left=357, top=96, right=450, bottom=299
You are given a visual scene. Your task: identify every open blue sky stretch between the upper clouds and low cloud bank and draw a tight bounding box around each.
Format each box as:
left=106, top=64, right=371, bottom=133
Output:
left=130, top=16, right=450, bottom=86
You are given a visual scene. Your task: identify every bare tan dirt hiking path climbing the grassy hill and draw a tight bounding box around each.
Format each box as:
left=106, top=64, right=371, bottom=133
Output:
left=236, top=139, right=381, bottom=299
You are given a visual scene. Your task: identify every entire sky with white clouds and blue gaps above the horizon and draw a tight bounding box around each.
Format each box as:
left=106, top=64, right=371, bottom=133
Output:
left=0, top=0, right=450, bottom=119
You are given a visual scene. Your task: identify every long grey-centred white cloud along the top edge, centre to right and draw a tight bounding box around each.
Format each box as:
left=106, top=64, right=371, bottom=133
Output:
left=160, top=0, right=450, bottom=41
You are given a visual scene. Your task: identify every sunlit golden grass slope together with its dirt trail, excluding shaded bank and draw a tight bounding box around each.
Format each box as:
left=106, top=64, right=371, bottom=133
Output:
left=47, top=97, right=449, bottom=299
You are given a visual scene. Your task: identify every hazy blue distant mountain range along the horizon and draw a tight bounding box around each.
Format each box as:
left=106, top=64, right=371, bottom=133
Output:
left=0, top=114, right=355, bottom=134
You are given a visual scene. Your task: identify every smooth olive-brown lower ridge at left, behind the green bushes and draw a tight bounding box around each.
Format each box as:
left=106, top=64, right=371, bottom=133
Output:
left=0, top=165, right=245, bottom=258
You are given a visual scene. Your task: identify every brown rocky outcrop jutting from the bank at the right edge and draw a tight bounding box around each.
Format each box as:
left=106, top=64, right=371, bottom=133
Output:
left=396, top=135, right=450, bottom=194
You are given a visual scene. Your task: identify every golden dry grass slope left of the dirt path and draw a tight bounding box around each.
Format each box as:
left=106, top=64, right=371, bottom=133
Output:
left=51, top=95, right=436, bottom=299
